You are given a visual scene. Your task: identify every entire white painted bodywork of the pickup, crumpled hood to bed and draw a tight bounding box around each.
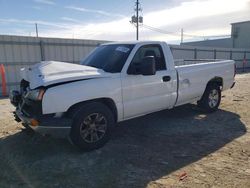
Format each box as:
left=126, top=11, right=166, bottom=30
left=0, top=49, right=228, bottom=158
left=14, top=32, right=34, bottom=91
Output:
left=21, top=42, right=234, bottom=121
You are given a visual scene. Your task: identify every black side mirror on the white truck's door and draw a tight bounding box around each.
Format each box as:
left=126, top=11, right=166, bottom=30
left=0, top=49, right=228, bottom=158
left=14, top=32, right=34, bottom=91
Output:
left=140, top=56, right=156, bottom=76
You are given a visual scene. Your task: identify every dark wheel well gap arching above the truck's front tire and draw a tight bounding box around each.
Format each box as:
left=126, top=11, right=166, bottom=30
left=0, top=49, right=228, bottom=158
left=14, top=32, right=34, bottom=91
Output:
left=66, top=98, right=118, bottom=121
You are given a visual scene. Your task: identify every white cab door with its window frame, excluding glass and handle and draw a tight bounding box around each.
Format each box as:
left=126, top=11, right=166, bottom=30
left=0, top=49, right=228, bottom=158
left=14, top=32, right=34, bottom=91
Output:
left=121, top=42, right=177, bottom=119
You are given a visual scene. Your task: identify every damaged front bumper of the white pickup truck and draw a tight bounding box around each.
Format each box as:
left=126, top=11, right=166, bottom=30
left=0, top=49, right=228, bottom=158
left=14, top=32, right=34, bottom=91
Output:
left=10, top=90, right=72, bottom=138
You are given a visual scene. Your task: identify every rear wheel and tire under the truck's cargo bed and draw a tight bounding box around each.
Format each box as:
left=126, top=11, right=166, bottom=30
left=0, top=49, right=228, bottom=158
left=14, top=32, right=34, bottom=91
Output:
left=197, top=83, right=221, bottom=112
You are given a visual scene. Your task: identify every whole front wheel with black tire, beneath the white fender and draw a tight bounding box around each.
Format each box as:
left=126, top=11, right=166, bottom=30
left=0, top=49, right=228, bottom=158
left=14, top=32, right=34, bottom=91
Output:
left=70, top=102, right=115, bottom=151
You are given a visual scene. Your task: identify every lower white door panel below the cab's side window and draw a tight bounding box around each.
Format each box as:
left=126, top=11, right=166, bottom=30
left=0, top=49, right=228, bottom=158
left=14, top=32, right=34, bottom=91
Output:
left=121, top=71, right=176, bottom=119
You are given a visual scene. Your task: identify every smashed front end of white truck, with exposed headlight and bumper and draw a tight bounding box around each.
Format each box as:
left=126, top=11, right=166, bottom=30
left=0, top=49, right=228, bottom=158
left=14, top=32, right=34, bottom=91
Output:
left=9, top=80, right=72, bottom=137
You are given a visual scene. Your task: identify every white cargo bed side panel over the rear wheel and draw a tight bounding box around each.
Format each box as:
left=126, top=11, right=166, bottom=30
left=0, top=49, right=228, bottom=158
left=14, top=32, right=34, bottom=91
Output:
left=176, top=60, right=234, bottom=106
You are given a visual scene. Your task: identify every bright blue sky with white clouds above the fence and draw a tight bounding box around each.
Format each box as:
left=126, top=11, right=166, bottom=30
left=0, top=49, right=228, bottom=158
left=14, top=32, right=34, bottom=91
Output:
left=0, top=0, right=250, bottom=43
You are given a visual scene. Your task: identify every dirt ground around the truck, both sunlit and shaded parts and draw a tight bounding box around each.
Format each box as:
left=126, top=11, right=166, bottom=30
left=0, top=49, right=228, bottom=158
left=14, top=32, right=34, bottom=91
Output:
left=0, top=73, right=250, bottom=188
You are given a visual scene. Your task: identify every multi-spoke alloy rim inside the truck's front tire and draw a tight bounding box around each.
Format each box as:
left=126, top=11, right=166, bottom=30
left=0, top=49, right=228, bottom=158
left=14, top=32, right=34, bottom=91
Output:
left=80, top=113, right=107, bottom=143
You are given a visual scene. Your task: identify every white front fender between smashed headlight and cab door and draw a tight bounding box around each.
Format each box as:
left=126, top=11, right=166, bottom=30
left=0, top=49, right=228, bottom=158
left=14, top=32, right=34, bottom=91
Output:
left=42, top=77, right=123, bottom=120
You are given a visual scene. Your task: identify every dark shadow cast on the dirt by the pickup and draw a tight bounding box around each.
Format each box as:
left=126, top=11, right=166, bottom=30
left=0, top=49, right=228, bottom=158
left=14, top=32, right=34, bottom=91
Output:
left=0, top=105, right=246, bottom=187
